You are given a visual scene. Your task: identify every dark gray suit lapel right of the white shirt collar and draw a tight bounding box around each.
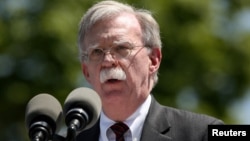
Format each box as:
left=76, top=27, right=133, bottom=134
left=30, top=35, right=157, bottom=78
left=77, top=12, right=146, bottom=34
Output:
left=141, top=96, right=171, bottom=141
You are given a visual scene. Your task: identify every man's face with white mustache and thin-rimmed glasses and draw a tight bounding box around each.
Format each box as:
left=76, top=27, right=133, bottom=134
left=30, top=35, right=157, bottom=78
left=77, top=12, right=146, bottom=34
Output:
left=82, top=13, right=160, bottom=107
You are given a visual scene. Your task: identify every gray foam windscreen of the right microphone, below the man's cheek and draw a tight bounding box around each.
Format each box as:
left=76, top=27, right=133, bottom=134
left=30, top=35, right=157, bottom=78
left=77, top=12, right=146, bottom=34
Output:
left=63, top=87, right=101, bottom=129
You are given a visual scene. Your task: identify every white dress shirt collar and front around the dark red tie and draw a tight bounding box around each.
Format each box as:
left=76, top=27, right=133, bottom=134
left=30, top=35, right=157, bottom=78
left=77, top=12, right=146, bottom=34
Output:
left=99, top=95, right=151, bottom=141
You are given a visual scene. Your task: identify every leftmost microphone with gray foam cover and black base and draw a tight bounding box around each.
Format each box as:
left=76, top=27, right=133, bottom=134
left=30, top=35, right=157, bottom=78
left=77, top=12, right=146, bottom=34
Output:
left=25, top=93, right=62, bottom=141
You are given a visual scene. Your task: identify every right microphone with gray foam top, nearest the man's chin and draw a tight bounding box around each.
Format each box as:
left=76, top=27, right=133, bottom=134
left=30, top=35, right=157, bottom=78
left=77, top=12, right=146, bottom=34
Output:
left=63, top=87, right=101, bottom=134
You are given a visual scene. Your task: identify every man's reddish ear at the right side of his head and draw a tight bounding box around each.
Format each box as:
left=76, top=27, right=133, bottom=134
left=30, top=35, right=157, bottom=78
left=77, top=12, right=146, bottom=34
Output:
left=149, top=47, right=162, bottom=73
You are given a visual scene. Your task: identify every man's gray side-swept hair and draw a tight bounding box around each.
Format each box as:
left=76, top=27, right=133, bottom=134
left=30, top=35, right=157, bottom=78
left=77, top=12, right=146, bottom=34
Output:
left=78, top=0, right=161, bottom=85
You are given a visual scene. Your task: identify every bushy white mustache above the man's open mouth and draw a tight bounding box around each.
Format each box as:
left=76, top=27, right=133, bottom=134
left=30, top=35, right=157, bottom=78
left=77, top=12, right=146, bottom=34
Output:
left=100, top=68, right=126, bottom=83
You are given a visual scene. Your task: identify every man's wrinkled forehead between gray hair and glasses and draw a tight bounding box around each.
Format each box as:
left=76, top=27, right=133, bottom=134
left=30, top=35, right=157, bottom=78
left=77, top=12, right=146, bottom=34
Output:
left=84, top=13, right=141, bottom=48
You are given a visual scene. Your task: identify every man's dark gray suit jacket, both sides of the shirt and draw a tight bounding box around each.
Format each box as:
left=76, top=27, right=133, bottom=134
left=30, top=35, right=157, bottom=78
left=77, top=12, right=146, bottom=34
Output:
left=76, top=97, right=224, bottom=141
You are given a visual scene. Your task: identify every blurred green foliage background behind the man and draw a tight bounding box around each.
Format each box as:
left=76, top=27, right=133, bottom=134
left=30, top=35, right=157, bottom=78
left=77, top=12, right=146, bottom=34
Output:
left=0, top=0, right=250, bottom=141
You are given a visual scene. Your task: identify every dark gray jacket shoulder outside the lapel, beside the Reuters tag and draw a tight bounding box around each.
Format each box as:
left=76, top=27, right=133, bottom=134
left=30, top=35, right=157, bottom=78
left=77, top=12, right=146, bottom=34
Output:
left=159, top=103, right=224, bottom=141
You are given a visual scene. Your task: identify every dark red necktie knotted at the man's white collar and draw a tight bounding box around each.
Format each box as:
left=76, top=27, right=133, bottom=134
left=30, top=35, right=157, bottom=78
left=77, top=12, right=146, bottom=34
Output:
left=110, top=122, right=129, bottom=141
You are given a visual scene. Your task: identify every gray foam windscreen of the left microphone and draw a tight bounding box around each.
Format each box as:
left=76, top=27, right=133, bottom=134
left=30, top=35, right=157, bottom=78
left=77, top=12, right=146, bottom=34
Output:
left=25, top=93, right=62, bottom=129
